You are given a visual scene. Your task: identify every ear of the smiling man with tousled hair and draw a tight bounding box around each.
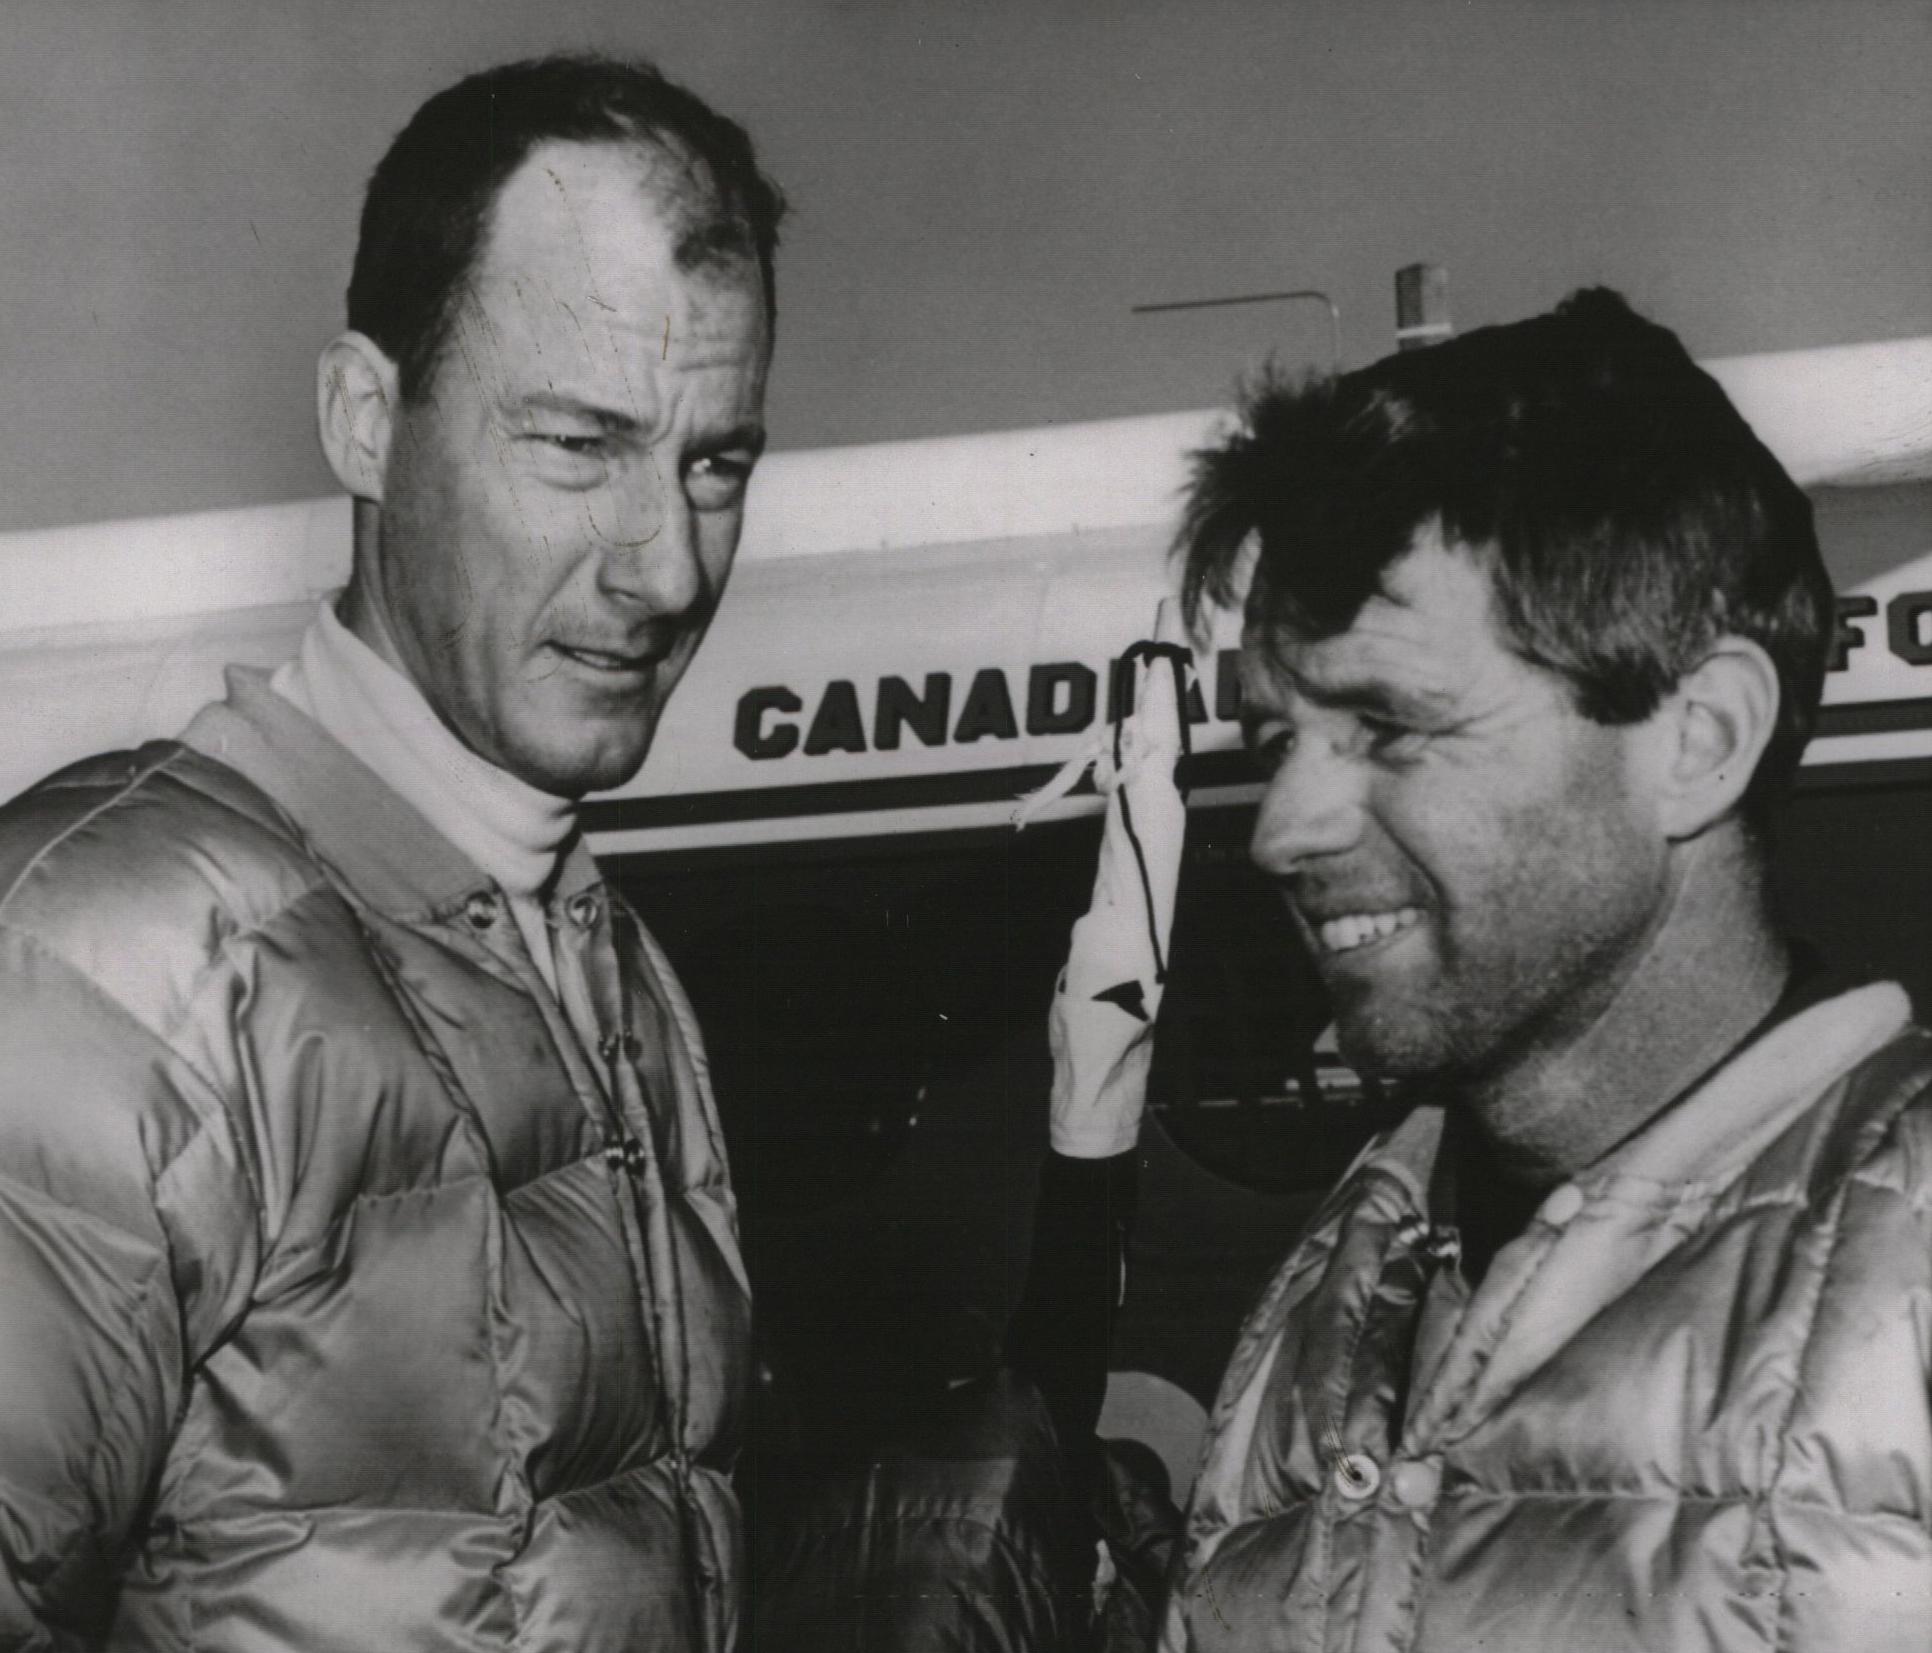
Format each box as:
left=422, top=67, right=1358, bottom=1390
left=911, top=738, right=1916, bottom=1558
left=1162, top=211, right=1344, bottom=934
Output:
left=1658, top=637, right=1779, bottom=840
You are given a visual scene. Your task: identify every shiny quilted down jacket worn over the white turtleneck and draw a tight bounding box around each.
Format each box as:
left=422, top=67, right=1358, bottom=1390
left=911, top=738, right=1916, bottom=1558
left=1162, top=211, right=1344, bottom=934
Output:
left=0, top=672, right=748, bottom=1653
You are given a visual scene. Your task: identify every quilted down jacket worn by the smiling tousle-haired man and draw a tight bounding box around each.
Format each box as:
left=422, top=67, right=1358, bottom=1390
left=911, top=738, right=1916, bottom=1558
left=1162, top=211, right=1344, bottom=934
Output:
left=1165, top=985, right=1932, bottom=1653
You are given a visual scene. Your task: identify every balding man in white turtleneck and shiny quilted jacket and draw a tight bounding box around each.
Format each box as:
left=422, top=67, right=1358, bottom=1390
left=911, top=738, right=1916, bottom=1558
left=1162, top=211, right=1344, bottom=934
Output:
left=0, top=58, right=781, bottom=1653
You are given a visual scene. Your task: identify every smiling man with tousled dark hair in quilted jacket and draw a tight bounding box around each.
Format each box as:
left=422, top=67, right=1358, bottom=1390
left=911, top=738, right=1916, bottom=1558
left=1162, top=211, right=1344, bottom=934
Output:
left=1167, top=292, right=1932, bottom=1653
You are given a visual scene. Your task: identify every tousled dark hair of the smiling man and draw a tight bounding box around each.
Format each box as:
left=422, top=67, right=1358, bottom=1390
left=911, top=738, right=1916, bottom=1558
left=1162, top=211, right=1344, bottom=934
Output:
left=1177, top=288, right=1835, bottom=817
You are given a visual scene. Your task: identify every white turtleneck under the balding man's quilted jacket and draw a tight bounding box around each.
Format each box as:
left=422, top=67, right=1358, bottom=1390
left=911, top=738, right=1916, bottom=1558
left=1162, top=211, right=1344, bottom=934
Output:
left=269, top=602, right=578, bottom=995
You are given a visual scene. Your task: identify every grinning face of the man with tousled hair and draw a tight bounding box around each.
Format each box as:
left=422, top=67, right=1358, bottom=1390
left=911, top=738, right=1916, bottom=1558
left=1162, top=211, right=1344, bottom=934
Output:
left=1242, top=531, right=1669, bottom=1081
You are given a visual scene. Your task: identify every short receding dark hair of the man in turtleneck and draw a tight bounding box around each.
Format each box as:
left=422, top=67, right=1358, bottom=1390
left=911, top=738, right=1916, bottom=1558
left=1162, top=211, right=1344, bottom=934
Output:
left=348, top=56, right=784, bottom=400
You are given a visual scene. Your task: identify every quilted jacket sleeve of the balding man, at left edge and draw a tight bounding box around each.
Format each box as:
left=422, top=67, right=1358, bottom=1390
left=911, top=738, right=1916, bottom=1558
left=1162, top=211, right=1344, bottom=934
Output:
left=0, top=917, right=259, bottom=1649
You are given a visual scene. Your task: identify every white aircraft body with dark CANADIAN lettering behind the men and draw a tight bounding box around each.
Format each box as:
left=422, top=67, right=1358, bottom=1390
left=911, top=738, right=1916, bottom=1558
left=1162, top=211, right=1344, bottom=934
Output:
left=0, top=338, right=1932, bottom=857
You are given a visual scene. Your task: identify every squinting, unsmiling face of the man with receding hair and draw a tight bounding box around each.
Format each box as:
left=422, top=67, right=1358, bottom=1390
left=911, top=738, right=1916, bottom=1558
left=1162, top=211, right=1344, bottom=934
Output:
left=344, top=143, right=771, bottom=798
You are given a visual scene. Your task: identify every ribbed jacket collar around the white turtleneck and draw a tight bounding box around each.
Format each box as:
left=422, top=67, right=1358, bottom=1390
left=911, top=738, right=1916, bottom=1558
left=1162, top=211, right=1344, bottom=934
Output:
left=182, top=666, right=599, bottom=923
